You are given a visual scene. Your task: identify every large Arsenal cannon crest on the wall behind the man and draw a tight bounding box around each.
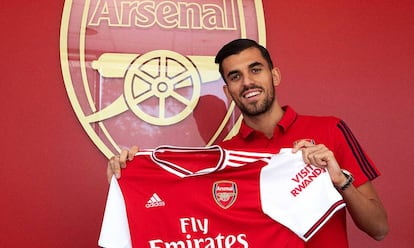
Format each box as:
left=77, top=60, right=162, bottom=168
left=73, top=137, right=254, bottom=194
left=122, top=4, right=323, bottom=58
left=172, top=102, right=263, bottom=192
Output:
left=60, top=0, right=266, bottom=158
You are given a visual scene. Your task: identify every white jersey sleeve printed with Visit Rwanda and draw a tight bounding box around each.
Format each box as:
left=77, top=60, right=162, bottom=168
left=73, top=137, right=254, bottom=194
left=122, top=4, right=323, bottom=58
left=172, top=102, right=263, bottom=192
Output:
left=260, top=149, right=345, bottom=241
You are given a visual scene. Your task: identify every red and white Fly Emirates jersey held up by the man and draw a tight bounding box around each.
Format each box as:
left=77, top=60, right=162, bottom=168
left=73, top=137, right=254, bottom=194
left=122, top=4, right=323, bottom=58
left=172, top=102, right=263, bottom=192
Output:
left=99, top=146, right=343, bottom=248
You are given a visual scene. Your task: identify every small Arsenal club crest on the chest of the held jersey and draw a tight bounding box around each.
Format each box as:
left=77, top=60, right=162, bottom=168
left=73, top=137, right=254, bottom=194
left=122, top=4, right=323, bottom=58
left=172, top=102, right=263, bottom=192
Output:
left=213, top=181, right=237, bottom=209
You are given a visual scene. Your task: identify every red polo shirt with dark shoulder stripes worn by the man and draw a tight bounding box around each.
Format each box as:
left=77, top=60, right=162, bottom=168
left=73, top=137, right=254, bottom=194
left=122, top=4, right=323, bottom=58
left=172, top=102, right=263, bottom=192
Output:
left=220, top=106, right=380, bottom=248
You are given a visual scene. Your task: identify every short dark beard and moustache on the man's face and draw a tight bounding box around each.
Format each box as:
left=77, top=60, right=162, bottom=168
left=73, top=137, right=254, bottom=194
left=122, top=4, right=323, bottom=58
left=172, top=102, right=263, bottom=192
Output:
left=235, top=86, right=275, bottom=117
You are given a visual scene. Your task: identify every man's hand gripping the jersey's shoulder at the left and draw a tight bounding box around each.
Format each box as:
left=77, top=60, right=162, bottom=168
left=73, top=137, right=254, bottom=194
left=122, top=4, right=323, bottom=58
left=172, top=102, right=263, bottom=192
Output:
left=106, top=146, right=139, bottom=182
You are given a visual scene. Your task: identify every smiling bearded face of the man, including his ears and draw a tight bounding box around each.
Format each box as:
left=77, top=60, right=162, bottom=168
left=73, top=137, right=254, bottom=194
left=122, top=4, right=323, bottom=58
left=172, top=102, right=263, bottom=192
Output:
left=222, top=48, right=279, bottom=116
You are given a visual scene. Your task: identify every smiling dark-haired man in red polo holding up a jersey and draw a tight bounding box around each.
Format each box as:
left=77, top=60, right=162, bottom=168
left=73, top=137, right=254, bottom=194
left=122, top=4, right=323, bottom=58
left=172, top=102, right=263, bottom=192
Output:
left=107, top=39, right=388, bottom=248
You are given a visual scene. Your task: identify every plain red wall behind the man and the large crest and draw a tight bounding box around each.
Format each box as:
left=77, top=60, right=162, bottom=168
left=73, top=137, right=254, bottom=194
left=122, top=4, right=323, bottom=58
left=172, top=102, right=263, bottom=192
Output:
left=0, top=0, right=414, bottom=248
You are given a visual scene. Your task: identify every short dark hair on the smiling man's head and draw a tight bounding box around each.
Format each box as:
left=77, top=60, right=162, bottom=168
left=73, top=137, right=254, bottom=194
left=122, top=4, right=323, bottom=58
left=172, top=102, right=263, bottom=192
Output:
left=215, top=39, right=273, bottom=79
